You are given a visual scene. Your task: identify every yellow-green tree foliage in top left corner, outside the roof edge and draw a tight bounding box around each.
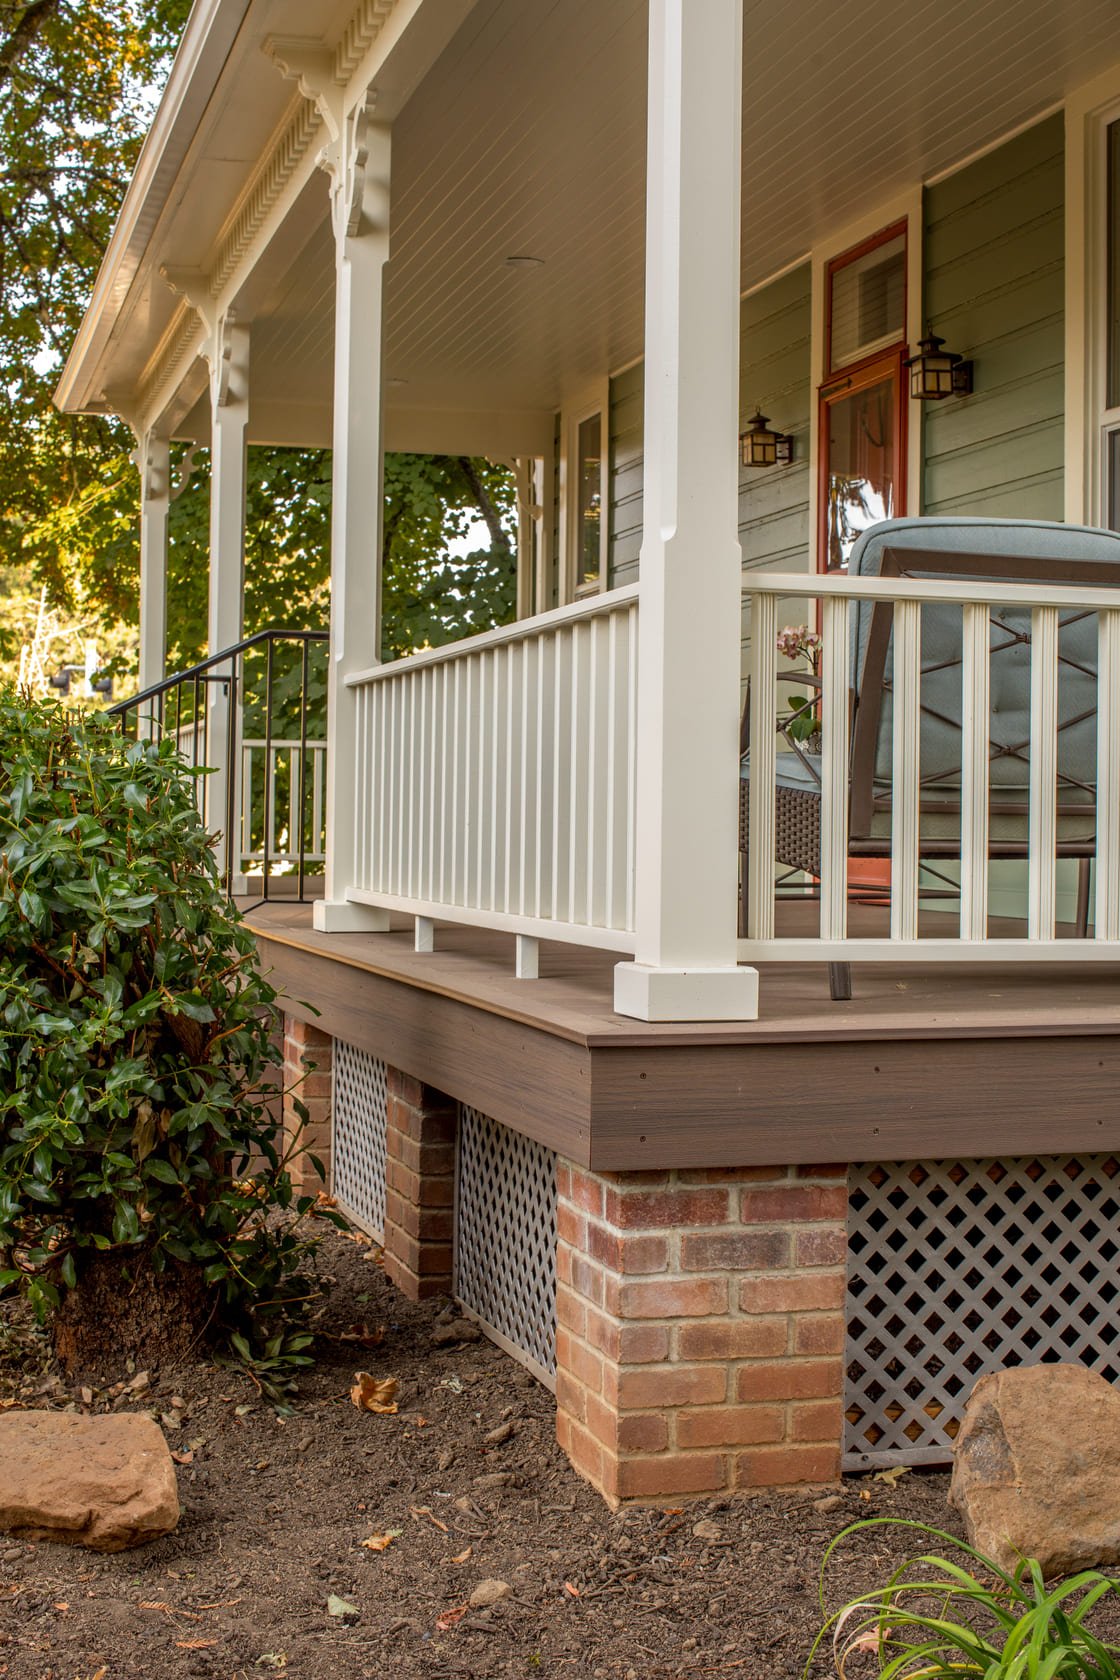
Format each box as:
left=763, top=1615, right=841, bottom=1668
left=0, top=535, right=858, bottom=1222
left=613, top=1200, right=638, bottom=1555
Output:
left=0, top=0, right=190, bottom=600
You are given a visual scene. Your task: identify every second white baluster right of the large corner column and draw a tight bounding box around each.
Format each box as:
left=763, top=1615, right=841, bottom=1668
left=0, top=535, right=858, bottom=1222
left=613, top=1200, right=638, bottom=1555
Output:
left=819, top=595, right=851, bottom=939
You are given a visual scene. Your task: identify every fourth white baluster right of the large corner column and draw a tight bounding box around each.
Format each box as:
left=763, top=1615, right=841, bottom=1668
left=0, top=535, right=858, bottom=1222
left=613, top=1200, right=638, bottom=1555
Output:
left=960, top=601, right=991, bottom=939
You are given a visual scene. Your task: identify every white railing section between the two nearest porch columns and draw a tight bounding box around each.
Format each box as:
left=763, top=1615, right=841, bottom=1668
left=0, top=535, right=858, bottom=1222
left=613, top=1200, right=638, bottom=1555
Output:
left=346, top=586, right=638, bottom=951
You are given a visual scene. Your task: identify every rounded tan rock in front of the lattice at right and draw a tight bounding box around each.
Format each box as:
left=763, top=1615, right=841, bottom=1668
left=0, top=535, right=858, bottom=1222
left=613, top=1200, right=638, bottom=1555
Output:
left=949, top=1364, right=1120, bottom=1579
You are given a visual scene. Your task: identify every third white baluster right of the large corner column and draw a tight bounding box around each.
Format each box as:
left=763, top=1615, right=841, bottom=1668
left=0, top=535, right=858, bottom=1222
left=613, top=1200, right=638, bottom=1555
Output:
left=890, top=601, right=922, bottom=939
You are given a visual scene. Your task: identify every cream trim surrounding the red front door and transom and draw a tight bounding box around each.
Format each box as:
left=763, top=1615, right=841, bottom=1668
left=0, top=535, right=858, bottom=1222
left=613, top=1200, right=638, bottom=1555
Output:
left=806, top=183, right=924, bottom=571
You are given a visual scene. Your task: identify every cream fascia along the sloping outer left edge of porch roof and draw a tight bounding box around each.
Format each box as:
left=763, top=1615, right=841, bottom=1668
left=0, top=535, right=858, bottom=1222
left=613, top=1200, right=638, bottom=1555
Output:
left=54, top=0, right=252, bottom=412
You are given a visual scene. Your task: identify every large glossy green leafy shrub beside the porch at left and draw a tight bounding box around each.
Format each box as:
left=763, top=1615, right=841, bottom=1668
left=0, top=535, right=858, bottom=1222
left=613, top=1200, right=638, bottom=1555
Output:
left=0, top=697, right=329, bottom=1362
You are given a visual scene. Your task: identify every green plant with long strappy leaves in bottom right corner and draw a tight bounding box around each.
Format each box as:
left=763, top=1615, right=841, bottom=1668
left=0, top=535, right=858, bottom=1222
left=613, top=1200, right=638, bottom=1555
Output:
left=804, top=1517, right=1120, bottom=1680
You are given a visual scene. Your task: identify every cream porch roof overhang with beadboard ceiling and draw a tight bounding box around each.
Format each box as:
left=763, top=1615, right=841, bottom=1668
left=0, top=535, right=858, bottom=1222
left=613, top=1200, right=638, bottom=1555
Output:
left=57, top=0, right=1120, bottom=455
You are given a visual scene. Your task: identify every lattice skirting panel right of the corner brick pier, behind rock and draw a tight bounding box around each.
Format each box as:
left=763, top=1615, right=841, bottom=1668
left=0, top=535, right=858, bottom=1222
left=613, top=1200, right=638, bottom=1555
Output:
left=845, top=1156, right=1120, bottom=1468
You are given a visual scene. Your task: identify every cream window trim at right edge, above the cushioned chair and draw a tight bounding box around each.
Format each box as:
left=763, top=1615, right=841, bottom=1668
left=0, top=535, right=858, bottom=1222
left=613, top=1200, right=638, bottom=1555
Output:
left=1065, top=66, right=1120, bottom=524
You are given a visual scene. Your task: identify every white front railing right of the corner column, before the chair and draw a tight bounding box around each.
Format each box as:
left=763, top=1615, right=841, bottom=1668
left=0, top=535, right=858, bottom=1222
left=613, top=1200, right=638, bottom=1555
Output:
left=739, top=573, right=1120, bottom=963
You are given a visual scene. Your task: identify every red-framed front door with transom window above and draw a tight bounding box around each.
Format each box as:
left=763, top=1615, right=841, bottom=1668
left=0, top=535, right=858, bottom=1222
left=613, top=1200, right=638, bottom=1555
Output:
left=818, top=222, right=907, bottom=571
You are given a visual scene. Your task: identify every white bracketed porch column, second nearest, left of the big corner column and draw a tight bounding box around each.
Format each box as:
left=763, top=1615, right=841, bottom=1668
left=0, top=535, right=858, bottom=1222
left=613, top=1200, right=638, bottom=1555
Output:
left=314, top=96, right=390, bottom=932
